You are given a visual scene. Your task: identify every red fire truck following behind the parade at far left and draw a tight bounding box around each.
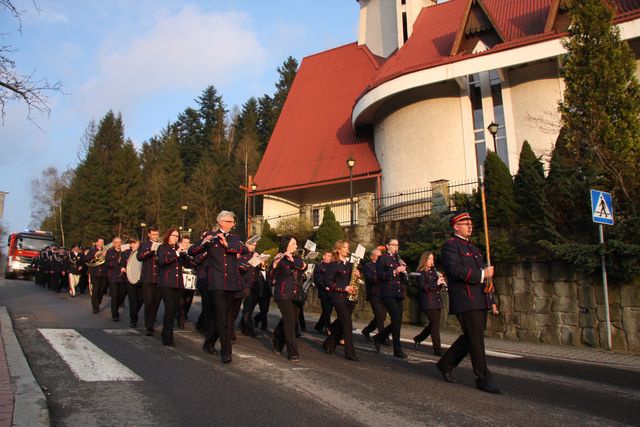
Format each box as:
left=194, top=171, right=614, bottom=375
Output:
left=5, top=230, right=56, bottom=279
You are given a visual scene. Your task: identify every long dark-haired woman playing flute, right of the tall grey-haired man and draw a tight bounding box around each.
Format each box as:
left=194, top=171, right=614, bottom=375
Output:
left=272, top=236, right=307, bottom=362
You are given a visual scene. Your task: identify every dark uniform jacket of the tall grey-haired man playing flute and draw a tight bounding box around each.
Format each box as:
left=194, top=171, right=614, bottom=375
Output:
left=189, top=231, right=242, bottom=291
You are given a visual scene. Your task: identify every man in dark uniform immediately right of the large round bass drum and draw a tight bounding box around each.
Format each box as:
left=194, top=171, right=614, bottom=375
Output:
left=136, top=227, right=160, bottom=336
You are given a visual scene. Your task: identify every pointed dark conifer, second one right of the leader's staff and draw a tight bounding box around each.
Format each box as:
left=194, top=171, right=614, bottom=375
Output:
left=513, top=141, right=559, bottom=242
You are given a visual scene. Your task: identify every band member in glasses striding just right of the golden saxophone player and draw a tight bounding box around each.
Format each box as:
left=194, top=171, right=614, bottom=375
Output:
left=373, top=239, right=407, bottom=359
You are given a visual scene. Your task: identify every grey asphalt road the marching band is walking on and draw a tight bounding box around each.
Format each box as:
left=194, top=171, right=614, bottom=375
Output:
left=0, top=280, right=640, bottom=426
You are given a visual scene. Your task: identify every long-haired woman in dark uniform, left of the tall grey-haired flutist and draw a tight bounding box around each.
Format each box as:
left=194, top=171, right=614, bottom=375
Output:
left=158, top=228, right=187, bottom=346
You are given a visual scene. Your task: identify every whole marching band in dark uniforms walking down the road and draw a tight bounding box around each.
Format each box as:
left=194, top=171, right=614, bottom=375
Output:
left=28, top=211, right=500, bottom=393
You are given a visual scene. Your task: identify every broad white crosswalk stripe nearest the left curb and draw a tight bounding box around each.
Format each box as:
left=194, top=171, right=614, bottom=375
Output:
left=38, top=329, right=142, bottom=382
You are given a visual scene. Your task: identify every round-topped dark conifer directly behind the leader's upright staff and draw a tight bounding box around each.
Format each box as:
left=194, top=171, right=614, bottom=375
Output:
left=484, top=151, right=517, bottom=227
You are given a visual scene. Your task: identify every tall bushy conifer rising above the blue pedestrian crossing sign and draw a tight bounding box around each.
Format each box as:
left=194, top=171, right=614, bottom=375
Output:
left=560, top=0, right=640, bottom=217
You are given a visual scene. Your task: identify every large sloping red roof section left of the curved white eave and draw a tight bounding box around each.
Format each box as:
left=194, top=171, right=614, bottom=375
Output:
left=255, top=43, right=381, bottom=193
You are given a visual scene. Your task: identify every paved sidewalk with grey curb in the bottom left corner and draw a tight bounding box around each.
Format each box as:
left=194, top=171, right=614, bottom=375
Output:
left=0, top=307, right=50, bottom=427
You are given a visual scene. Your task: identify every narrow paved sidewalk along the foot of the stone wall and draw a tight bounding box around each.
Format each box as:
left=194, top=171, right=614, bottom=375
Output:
left=290, top=306, right=640, bottom=371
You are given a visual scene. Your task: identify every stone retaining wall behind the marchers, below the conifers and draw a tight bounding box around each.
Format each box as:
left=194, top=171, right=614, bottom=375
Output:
left=305, top=262, right=640, bottom=352
